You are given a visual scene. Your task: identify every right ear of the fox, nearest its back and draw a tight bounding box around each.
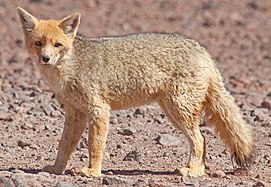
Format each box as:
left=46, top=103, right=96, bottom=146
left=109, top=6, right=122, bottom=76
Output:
left=59, top=12, right=81, bottom=38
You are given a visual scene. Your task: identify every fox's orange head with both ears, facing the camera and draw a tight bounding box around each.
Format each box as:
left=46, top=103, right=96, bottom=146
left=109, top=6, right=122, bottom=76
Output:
left=17, top=8, right=80, bottom=68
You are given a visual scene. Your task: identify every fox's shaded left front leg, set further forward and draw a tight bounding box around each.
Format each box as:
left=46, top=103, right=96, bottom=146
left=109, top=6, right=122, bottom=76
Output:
left=42, top=105, right=87, bottom=174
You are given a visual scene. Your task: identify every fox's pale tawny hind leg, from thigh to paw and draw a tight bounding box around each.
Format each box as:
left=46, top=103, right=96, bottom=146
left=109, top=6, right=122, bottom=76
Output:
left=160, top=96, right=205, bottom=177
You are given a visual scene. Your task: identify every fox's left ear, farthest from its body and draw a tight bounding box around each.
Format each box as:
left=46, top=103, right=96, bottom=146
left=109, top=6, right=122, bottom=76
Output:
left=17, top=7, right=38, bottom=33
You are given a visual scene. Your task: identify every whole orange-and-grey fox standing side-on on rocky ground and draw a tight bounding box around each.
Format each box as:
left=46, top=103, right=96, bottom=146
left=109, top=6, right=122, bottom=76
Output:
left=18, top=8, right=253, bottom=176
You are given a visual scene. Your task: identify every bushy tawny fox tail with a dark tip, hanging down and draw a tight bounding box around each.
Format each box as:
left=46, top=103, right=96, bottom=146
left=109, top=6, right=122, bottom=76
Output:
left=204, top=71, right=253, bottom=167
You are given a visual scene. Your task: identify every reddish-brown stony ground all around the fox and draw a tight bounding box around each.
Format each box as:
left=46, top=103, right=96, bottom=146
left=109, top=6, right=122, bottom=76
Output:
left=0, top=0, right=271, bottom=187
